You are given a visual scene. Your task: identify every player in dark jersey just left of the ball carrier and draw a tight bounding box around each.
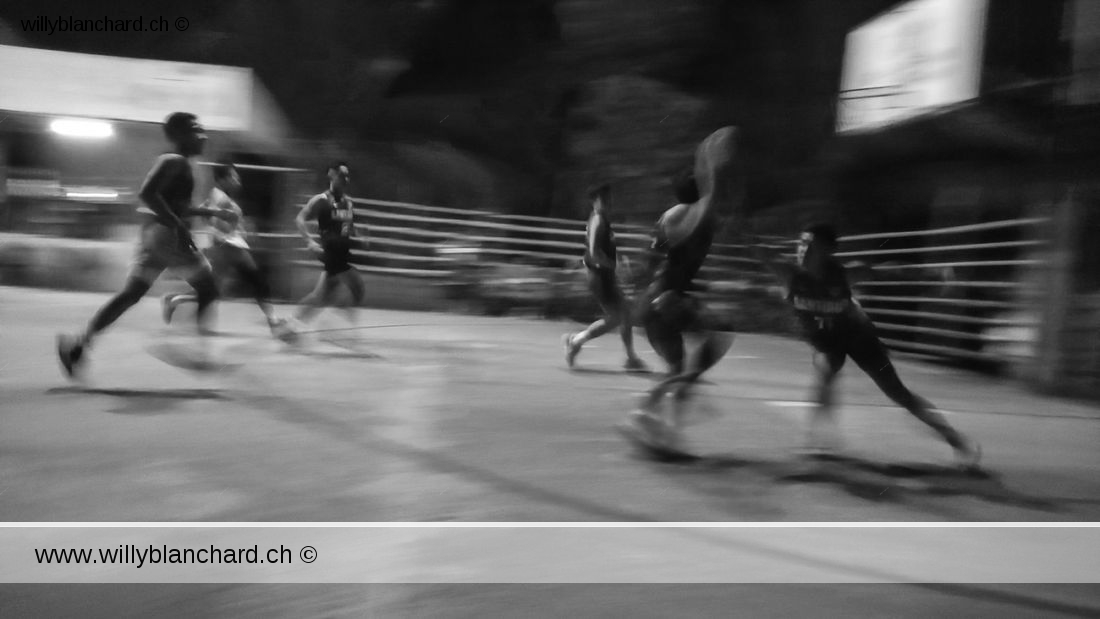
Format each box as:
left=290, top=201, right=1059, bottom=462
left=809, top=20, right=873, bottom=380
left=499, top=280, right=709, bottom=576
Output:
left=562, top=185, right=646, bottom=372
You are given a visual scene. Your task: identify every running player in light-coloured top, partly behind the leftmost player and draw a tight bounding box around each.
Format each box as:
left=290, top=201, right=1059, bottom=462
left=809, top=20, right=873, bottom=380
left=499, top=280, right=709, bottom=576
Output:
left=162, top=163, right=285, bottom=334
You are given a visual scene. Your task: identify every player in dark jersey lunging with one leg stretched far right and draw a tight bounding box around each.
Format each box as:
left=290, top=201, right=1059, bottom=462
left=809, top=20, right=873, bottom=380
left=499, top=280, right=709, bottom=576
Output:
left=757, top=224, right=981, bottom=468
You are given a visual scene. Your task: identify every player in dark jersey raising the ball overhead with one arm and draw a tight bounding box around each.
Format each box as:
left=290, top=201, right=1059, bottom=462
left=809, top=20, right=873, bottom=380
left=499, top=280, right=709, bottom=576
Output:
left=620, top=126, right=744, bottom=450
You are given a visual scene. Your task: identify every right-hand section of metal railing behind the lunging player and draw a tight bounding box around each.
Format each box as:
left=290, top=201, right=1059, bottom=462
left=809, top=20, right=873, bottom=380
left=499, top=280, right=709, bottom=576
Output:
left=837, top=218, right=1048, bottom=363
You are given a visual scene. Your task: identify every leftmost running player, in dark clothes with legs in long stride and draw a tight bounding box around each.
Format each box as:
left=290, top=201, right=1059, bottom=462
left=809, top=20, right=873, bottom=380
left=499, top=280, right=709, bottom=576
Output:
left=57, top=112, right=233, bottom=377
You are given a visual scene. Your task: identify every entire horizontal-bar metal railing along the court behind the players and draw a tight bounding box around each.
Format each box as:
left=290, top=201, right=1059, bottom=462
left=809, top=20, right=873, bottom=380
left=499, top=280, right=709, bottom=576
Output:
left=267, top=199, right=1047, bottom=362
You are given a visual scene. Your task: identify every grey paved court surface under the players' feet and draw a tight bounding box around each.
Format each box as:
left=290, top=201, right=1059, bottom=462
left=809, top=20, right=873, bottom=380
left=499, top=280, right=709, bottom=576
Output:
left=0, top=288, right=1100, bottom=617
